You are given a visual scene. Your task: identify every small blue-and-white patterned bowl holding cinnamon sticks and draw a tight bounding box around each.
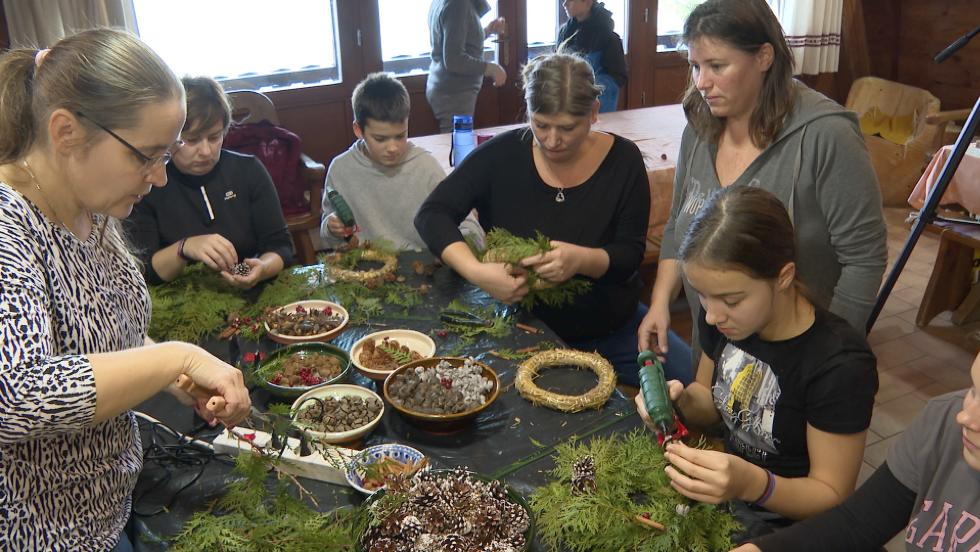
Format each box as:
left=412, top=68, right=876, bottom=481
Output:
left=347, top=443, right=429, bottom=494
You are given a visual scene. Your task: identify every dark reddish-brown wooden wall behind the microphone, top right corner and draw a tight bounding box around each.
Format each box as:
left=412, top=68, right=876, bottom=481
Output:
left=896, top=0, right=980, bottom=110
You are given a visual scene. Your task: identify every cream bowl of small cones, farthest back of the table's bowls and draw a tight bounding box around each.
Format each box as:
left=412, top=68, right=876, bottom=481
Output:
left=265, top=299, right=350, bottom=345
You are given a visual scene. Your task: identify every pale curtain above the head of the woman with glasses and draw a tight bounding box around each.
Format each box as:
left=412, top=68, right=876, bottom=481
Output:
left=3, top=0, right=136, bottom=48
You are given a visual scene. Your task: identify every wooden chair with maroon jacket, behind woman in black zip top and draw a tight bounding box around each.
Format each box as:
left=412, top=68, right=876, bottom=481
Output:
left=228, top=90, right=327, bottom=265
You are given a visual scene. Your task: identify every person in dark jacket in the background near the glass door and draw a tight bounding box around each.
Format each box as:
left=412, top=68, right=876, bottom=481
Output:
left=558, top=0, right=627, bottom=113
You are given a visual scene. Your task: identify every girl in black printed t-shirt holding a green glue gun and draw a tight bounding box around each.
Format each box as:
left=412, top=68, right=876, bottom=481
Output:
left=636, top=186, right=878, bottom=536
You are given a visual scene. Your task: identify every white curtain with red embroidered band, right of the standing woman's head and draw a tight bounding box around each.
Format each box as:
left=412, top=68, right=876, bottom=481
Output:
left=769, top=0, right=844, bottom=75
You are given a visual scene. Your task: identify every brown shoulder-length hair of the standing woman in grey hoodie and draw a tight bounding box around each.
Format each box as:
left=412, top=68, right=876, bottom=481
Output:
left=681, top=0, right=796, bottom=148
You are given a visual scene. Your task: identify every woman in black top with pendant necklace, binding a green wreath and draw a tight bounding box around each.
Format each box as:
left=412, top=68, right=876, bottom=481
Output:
left=415, top=54, right=688, bottom=383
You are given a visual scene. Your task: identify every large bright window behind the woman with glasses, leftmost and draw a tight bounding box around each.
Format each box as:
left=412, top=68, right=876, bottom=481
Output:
left=133, top=0, right=340, bottom=90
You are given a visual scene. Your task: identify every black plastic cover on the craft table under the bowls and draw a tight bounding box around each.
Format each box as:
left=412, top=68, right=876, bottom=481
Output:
left=133, top=253, right=642, bottom=550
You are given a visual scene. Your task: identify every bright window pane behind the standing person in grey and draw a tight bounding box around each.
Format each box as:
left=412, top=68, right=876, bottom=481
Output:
left=378, top=0, right=497, bottom=75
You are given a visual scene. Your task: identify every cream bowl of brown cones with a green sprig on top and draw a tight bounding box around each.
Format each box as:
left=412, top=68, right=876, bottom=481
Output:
left=350, top=330, right=436, bottom=381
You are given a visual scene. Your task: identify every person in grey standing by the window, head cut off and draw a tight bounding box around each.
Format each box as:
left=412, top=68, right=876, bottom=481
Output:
left=425, top=0, right=507, bottom=132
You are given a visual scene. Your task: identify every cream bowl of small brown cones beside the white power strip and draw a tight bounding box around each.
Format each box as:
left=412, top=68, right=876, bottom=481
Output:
left=292, top=384, right=384, bottom=443
